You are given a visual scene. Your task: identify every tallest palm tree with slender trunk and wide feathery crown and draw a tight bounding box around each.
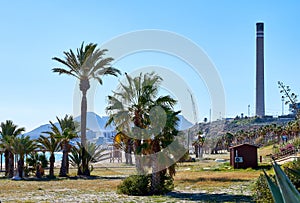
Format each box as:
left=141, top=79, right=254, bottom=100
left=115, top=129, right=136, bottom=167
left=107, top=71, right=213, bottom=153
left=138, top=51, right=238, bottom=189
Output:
left=52, top=43, right=120, bottom=175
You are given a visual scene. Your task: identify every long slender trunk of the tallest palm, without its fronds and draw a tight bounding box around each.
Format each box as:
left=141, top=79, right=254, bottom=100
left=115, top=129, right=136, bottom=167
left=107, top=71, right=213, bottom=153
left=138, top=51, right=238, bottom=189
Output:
left=80, top=79, right=90, bottom=176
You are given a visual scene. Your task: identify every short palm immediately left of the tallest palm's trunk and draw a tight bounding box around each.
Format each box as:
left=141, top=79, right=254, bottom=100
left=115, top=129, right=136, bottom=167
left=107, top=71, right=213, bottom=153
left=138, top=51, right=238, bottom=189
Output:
left=44, top=115, right=77, bottom=177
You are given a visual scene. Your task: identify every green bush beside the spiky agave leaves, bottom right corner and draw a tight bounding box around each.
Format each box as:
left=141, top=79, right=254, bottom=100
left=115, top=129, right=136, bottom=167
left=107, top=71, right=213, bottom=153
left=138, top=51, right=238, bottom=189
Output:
left=254, top=174, right=275, bottom=203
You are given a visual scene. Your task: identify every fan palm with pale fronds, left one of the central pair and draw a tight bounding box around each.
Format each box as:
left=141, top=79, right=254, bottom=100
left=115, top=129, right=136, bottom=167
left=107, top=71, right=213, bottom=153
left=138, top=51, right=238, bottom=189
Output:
left=106, top=72, right=162, bottom=173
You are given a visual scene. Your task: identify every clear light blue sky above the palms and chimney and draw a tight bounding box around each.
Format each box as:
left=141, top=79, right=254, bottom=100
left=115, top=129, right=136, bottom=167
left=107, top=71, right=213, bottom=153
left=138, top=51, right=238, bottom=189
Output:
left=0, top=0, right=300, bottom=131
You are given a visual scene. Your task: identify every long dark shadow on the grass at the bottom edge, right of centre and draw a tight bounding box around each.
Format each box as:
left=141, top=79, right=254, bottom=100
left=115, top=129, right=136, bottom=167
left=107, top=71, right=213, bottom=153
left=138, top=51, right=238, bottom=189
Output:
left=167, top=192, right=255, bottom=202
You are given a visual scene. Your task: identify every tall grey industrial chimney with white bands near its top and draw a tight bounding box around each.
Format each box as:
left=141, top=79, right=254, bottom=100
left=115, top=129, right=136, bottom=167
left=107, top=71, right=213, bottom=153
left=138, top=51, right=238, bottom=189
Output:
left=256, top=23, right=265, bottom=117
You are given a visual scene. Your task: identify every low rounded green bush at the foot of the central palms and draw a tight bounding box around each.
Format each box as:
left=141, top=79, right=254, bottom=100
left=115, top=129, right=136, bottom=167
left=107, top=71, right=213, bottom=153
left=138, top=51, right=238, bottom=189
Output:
left=117, top=175, right=151, bottom=195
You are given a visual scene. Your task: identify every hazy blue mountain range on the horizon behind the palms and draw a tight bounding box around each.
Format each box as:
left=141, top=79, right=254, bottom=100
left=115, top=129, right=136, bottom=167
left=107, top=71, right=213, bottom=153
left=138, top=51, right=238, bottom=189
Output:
left=25, top=112, right=193, bottom=139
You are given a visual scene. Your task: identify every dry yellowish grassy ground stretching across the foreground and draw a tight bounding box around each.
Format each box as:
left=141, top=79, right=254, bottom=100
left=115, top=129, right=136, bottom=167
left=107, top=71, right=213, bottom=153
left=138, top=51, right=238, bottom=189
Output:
left=0, top=152, right=268, bottom=203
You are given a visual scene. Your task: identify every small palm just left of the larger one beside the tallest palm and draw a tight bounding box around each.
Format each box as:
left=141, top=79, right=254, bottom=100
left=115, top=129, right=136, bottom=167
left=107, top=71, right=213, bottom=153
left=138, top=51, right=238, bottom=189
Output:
left=37, top=135, right=60, bottom=178
